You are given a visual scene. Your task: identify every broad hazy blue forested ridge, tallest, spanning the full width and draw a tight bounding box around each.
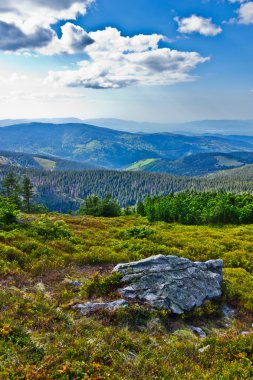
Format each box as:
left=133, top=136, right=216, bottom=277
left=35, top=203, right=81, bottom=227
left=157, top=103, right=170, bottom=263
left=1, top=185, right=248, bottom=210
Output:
left=0, top=123, right=253, bottom=169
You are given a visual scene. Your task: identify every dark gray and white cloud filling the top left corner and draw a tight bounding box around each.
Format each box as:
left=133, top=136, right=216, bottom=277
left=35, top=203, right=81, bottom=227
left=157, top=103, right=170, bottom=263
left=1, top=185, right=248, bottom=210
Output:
left=0, top=0, right=95, bottom=54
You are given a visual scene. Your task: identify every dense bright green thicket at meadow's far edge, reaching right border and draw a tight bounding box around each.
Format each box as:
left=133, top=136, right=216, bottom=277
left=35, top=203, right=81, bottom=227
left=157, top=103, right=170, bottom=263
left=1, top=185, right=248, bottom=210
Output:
left=137, top=191, right=253, bottom=225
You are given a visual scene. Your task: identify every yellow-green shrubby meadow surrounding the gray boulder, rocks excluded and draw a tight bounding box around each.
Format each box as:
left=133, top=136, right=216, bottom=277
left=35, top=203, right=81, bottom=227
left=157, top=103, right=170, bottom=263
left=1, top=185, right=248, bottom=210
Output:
left=0, top=214, right=253, bottom=380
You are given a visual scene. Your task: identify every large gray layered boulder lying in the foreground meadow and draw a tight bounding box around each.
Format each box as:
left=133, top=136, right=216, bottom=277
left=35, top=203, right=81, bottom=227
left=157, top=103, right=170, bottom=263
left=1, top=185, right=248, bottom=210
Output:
left=113, top=255, right=223, bottom=314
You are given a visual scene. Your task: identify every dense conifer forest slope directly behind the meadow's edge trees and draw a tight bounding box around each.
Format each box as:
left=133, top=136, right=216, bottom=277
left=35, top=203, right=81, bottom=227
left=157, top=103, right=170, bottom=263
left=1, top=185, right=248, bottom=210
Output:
left=0, top=166, right=253, bottom=212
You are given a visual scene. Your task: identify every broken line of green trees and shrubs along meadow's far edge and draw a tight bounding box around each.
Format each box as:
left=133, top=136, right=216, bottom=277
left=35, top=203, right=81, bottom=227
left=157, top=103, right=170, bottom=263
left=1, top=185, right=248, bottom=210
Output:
left=0, top=172, right=253, bottom=225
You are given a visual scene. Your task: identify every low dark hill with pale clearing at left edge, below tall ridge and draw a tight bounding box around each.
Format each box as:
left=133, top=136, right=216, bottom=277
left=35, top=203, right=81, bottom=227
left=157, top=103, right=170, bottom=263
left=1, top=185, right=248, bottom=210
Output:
left=0, top=150, right=97, bottom=170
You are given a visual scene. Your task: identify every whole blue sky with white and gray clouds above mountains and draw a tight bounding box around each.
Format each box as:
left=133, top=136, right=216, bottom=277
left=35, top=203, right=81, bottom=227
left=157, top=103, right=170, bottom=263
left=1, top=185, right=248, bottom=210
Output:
left=0, top=0, right=253, bottom=123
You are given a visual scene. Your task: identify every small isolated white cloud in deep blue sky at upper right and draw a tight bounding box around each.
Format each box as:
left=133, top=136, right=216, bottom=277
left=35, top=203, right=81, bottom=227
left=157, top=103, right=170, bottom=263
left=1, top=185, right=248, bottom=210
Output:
left=174, top=15, right=222, bottom=36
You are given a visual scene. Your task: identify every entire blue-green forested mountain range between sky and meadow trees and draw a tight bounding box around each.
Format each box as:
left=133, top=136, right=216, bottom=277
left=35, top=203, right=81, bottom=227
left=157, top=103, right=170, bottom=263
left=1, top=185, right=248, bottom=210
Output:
left=0, top=120, right=253, bottom=212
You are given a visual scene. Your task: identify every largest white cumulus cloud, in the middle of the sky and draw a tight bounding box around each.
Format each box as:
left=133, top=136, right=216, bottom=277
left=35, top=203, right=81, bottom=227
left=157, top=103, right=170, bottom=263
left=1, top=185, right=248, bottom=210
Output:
left=45, top=27, right=209, bottom=89
